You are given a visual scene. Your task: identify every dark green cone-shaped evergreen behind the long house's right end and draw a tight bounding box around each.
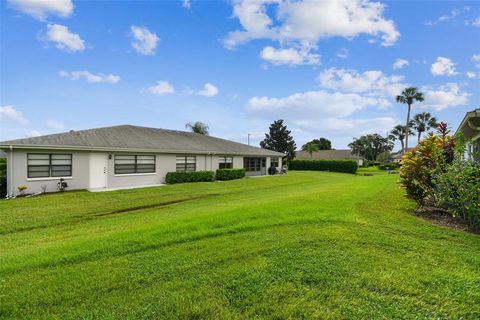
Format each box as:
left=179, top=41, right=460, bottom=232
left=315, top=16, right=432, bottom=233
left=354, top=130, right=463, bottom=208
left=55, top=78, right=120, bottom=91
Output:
left=260, top=120, right=296, bottom=160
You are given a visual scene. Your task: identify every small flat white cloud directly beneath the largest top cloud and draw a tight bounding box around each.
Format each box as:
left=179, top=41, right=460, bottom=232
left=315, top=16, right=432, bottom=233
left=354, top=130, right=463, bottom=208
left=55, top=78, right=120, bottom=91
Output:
left=260, top=46, right=320, bottom=65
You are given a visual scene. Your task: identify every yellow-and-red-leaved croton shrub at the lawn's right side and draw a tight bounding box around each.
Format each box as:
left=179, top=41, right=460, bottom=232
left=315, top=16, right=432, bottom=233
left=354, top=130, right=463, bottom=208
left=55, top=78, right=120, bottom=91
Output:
left=400, top=133, right=455, bottom=204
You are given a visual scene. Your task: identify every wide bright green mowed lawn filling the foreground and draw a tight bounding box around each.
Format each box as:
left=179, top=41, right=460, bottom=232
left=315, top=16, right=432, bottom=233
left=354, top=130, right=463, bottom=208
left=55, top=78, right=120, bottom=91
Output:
left=0, top=172, right=480, bottom=319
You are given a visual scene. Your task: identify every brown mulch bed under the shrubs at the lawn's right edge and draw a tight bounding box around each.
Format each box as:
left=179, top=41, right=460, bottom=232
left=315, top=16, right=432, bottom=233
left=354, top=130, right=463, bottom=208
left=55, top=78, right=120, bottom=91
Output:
left=415, top=206, right=480, bottom=234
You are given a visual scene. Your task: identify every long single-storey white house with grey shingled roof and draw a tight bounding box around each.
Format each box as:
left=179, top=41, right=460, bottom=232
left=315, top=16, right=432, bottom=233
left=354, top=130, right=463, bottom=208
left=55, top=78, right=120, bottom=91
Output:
left=0, top=125, right=284, bottom=195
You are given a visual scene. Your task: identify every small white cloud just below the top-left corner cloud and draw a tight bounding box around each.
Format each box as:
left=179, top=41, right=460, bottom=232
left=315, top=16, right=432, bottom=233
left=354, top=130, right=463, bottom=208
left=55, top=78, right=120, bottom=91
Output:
left=40, top=24, right=85, bottom=53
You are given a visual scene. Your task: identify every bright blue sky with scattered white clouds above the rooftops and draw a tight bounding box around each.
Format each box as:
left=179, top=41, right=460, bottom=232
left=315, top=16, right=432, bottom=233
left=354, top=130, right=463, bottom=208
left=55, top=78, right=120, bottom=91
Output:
left=0, top=0, right=480, bottom=149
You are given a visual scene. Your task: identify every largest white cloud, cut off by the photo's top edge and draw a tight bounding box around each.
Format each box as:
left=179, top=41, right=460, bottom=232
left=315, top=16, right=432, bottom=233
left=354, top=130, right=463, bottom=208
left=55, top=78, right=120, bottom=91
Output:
left=223, top=0, right=400, bottom=65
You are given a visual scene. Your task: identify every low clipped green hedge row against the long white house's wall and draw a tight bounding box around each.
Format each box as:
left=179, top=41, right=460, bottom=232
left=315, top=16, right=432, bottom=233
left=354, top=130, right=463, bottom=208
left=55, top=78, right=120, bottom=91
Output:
left=165, top=169, right=245, bottom=184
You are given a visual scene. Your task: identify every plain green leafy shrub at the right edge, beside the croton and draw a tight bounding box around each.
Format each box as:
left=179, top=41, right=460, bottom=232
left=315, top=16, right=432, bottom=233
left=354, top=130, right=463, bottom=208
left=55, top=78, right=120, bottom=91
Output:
left=434, top=142, right=480, bottom=227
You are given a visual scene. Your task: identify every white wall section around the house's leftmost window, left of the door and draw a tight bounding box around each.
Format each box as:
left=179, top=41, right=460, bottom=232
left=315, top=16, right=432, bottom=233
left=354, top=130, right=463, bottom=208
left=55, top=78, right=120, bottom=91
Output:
left=7, top=149, right=89, bottom=195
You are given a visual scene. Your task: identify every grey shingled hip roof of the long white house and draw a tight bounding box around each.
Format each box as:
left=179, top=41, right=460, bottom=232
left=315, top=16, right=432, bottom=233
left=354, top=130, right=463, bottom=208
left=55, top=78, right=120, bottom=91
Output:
left=0, top=125, right=283, bottom=157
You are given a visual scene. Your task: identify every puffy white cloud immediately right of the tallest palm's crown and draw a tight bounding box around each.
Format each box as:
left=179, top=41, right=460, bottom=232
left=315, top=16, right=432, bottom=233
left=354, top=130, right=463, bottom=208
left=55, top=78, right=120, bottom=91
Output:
left=418, top=83, right=471, bottom=111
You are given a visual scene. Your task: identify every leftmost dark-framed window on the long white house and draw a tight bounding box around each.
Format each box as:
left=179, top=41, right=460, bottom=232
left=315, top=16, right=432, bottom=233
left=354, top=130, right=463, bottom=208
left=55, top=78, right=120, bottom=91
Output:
left=27, top=153, right=72, bottom=178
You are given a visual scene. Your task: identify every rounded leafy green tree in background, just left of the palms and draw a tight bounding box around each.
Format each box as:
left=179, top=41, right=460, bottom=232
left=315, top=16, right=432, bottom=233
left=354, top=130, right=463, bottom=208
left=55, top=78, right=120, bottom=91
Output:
left=348, top=133, right=393, bottom=161
